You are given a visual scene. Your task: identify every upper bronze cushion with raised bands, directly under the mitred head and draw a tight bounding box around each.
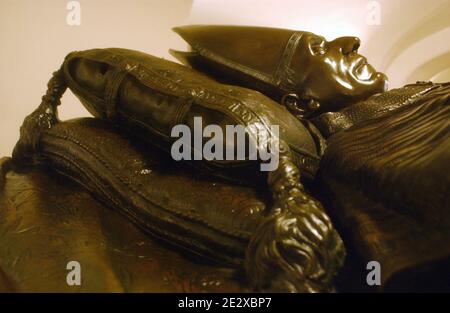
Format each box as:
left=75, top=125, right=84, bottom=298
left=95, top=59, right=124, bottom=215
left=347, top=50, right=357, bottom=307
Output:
left=62, top=49, right=320, bottom=178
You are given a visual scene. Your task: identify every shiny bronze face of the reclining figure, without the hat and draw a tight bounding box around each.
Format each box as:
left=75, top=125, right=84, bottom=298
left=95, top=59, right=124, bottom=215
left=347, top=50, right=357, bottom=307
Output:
left=294, top=33, right=387, bottom=111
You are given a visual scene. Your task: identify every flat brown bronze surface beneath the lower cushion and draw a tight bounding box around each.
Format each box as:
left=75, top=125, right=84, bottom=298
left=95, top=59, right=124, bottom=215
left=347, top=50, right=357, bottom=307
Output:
left=0, top=160, right=247, bottom=292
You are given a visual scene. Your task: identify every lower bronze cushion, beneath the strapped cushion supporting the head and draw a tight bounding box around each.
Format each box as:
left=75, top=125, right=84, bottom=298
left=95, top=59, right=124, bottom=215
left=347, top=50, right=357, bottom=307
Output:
left=39, top=118, right=270, bottom=265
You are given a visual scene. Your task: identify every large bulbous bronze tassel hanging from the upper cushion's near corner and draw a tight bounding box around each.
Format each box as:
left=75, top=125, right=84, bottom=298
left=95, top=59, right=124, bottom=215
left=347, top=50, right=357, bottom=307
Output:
left=244, top=142, right=345, bottom=292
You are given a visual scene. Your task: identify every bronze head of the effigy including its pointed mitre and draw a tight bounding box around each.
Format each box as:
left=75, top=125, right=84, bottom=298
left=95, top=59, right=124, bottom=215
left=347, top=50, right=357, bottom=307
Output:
left=173, top=25, right=387, bottom=116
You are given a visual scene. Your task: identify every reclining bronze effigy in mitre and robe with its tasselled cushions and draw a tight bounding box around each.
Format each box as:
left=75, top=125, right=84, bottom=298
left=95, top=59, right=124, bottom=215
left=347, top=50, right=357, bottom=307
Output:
left=2, top=26, right=450, bottom=292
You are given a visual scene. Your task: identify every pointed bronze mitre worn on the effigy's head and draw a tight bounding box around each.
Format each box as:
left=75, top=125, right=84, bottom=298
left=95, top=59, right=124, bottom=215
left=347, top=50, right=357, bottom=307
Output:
left=170, top=25, right=304, bottom=100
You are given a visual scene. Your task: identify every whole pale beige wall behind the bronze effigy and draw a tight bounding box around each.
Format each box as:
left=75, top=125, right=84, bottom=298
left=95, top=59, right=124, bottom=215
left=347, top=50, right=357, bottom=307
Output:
left=0, top=0, right=450, bottom=156
